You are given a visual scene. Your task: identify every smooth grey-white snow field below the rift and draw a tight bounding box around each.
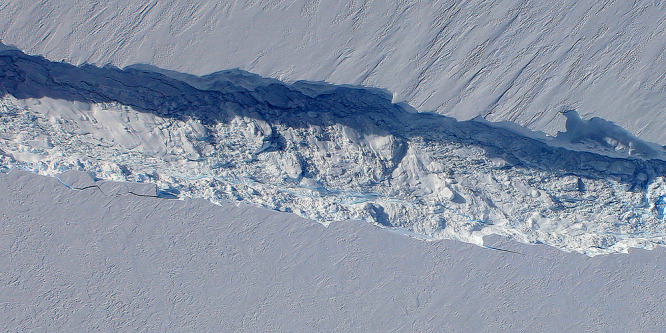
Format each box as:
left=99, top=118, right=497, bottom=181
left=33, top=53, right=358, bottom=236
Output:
left=0, top=170, right=666, bottom=332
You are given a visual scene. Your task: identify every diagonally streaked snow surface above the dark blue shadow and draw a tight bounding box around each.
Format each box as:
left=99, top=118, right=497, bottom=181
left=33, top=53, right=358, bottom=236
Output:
left=0, top=0, right=666, bottom=144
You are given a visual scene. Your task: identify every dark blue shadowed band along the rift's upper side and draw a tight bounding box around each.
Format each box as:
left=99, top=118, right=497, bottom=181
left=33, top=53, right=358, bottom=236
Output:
left=0, top=44, right=666, bottom=191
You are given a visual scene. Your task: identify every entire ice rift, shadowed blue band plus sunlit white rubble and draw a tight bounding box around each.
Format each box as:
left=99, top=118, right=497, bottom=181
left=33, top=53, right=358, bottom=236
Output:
left=0, top=51, right=666, bottom=255
